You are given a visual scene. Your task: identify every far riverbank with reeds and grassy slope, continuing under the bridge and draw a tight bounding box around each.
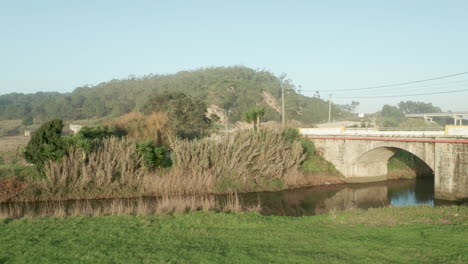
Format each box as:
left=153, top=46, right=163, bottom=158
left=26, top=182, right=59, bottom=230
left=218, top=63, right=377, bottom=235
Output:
left=0, top=129, right=436, bottom=202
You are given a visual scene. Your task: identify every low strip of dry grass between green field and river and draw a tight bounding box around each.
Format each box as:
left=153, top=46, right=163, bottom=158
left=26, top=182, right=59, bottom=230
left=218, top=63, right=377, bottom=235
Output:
left=0, top=193, right=261, bottom=219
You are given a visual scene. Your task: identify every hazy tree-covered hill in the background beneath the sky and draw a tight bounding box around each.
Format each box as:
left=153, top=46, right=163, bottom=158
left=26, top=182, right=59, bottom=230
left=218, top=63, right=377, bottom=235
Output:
left=0, top=66, right=349, bottom=124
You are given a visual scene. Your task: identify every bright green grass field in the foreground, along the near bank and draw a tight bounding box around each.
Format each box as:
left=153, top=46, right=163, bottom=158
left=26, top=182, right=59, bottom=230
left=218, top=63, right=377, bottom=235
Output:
left=0, top=206, right=468, bottom=263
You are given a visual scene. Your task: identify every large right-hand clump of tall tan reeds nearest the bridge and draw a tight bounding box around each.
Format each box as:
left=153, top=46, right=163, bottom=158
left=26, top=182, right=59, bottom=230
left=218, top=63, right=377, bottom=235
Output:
left=166, top=130, right=305, bottom=192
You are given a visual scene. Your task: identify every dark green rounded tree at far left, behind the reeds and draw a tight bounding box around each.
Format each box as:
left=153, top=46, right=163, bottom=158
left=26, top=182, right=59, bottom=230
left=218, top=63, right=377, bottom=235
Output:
left=23, top=119, right=66, bottom=171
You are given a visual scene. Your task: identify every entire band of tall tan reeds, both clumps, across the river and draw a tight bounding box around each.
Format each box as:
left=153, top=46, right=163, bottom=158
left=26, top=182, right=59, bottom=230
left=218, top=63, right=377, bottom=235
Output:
left=15, top=130, right=310, bottom=200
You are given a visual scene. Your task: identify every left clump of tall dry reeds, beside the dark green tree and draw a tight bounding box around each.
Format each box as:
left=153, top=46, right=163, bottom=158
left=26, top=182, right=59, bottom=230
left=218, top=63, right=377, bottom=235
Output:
left=25, top=138, right=157, bottom=199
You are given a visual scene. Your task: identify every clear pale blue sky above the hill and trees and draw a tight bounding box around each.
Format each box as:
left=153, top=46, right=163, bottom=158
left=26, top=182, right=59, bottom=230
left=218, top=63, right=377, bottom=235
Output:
left=0, top=0, right=468, bottom=112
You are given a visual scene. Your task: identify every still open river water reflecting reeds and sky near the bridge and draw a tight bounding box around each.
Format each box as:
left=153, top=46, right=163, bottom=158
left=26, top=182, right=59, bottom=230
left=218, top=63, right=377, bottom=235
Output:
left=239, top=177, right=448, bottom=216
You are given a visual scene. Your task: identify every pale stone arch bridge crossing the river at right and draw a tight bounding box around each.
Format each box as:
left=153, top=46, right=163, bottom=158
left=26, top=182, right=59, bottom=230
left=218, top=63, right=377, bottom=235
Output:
left=304, top=135, right=468, bottom=200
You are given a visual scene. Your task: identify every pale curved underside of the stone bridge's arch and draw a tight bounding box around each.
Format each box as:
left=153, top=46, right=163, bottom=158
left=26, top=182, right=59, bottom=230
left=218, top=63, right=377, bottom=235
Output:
left=352, top=144, right=435, bottom=177
